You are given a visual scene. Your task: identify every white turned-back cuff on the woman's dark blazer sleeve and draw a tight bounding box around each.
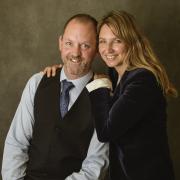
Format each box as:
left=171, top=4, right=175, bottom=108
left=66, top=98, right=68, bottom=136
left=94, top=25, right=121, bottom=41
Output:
left=86, top=78, right=112, bottom=92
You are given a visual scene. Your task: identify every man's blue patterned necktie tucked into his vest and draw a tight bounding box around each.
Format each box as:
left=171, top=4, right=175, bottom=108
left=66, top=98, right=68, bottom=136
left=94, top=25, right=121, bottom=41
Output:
left=60, top=80, right=74, bottom=117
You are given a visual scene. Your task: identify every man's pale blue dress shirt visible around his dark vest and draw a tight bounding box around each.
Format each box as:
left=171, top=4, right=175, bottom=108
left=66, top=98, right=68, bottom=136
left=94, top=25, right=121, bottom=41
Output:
left=2, top=69, right=109, bottom=180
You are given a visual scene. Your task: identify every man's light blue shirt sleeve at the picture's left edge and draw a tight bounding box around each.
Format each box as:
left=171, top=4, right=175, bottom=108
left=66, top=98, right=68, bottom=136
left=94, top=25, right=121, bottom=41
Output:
left=2, top=73, right=43, bottom=180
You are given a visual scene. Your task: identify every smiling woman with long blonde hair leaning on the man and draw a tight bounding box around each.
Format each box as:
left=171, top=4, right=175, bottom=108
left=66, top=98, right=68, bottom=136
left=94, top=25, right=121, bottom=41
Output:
left=43, top=11, right=177, bottom=180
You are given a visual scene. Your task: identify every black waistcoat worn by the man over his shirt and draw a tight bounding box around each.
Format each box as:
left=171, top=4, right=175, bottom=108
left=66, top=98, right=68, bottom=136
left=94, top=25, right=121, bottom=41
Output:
left=25, top=69, right=94, bottom=180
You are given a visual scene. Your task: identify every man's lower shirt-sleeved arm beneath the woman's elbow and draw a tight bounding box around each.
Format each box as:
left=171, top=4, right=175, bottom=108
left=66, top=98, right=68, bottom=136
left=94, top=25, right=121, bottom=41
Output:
left=65, top=131, right=109, bottom=180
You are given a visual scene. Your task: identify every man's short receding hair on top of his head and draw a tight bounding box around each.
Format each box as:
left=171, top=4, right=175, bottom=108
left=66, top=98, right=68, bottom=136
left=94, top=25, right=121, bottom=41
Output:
left=63, top=13, right=97, bottom=34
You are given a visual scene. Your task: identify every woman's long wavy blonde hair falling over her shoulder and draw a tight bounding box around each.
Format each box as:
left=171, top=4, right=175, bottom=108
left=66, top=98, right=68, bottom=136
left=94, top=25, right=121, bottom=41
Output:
left=98, top=11, right=178, bottom=97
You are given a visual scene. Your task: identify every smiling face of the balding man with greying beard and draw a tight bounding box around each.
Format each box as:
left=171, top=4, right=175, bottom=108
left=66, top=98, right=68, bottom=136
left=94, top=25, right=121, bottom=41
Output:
left=59, top=20, right=97, bottom=79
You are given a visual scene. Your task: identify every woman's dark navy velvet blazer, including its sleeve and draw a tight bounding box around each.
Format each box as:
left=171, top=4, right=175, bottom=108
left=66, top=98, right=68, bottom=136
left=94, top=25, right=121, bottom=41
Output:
left=90, top=68, right=174, bottom=180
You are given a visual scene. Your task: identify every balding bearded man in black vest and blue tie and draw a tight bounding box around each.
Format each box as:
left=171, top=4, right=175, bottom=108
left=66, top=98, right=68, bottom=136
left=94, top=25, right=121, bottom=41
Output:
left=2, top=14, right=108, bottom=180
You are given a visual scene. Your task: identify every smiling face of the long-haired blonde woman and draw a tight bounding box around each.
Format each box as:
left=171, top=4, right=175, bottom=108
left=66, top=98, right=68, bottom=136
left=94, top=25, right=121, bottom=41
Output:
left=99, top=24, right=127, bottom=71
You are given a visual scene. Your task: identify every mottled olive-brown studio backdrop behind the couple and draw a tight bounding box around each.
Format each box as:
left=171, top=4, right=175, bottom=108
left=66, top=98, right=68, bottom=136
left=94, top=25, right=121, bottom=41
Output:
left=0, top=0, right=180, bottom=179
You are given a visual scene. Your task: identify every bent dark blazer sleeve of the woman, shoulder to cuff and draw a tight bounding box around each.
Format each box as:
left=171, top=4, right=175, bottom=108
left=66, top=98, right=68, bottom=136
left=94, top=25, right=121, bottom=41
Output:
left=90, top=70, right=162, bottom=142
